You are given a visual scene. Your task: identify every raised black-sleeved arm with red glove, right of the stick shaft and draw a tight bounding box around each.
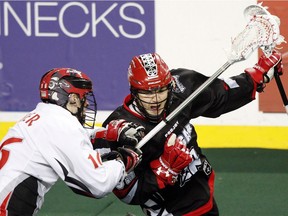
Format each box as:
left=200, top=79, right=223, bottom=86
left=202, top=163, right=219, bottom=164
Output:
left=195, top=51, right=283, bottom=118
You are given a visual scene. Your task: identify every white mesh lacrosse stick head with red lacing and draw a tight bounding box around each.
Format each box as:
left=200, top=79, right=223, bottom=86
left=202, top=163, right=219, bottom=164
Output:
left=228, top=4, right=284, bottom=62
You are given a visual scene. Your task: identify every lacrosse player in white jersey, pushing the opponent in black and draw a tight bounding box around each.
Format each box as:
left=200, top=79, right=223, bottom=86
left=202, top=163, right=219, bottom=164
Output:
left=0, top=68, right=140, bottom=216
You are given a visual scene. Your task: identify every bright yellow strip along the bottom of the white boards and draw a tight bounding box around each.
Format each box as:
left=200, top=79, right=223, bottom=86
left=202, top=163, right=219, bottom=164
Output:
left=0, top=122, right=288, bottom=149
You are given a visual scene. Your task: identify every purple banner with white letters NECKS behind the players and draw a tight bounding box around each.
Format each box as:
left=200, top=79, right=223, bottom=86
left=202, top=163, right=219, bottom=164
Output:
left=0, top=1, right=155, bottom=111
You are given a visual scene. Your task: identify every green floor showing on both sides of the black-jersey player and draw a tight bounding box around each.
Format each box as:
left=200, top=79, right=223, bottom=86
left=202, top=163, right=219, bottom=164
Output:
left=39, top=149, right=288, bottom=216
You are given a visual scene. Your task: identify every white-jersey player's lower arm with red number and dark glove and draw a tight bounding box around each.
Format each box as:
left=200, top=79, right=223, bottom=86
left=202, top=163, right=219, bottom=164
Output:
left=57, top=143, right=141, bottom=198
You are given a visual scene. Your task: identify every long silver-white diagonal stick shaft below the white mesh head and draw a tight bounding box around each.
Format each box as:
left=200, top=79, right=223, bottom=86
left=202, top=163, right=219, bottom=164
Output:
left=136, top=61, right=234, bottom=149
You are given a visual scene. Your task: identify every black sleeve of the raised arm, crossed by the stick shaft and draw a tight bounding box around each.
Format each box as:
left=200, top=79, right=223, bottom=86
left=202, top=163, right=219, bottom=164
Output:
left=173, top=69, right=255, bottom=118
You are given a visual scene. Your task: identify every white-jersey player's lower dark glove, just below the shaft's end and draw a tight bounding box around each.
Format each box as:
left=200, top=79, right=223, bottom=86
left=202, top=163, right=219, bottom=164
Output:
left=117, top=147, right=142, bottom=173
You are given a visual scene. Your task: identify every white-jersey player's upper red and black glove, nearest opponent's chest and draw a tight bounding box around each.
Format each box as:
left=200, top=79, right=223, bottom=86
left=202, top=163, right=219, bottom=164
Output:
left=106, top=119, right=145, bottom=147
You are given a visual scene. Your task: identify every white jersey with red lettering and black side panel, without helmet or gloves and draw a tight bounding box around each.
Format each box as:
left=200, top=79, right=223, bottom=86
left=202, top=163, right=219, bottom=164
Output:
left=0, top=103, right=125, bottom=216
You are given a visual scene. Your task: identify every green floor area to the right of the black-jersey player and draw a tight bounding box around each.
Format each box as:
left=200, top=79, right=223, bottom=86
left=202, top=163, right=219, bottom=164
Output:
left=204, top=149, right=288, bottom=216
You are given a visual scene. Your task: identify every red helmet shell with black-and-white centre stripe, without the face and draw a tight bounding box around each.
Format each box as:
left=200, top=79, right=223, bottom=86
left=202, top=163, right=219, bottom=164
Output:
left=128, top=53, right=172, bottom=90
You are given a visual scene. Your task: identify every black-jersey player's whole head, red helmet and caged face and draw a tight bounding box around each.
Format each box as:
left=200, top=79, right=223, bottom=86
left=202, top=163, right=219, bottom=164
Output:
left=128, top=53, right=173, bottom=122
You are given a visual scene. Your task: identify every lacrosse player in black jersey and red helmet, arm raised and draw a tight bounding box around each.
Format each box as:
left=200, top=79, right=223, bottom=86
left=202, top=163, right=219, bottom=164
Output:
left=103, top=51, right=282, bottom=216
